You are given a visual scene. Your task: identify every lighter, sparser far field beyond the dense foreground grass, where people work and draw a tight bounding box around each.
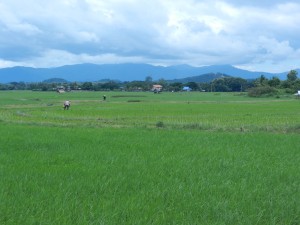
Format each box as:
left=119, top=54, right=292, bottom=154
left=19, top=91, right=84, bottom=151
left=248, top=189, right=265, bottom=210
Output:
left=0, top=92, right=300, bottom=133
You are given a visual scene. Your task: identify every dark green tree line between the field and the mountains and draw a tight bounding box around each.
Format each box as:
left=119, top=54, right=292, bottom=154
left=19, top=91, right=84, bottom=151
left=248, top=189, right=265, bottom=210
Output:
left=0, top=70, right=300, bottom=97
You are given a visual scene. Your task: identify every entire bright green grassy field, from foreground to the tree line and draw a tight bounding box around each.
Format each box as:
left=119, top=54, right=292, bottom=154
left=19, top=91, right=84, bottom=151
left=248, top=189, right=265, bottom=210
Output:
left=0, top=91, right=300, bottom=225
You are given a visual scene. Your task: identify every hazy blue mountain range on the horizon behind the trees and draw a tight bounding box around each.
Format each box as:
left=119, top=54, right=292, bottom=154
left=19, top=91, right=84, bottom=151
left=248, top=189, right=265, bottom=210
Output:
left=0, top=63, right=300, bottom=83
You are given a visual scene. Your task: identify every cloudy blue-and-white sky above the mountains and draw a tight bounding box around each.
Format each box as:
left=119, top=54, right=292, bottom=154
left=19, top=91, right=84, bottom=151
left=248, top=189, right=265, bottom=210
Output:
left=0, top=0, right=300, bottom=72
